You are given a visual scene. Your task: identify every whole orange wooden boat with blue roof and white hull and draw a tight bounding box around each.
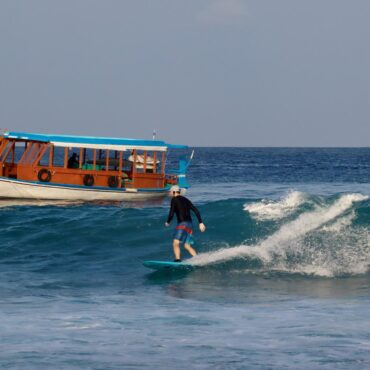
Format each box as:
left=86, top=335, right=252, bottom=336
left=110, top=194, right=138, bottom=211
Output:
left=0, top=131, right=194, bottom=201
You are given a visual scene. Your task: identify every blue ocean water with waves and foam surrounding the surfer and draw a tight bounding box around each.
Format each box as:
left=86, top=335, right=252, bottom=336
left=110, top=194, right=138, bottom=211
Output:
left=0, top=148, right=370, bottom=370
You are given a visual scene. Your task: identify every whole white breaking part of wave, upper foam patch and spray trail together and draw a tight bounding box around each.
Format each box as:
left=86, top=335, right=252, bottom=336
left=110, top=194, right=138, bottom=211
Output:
left=190, top=192, right=370, bottom=277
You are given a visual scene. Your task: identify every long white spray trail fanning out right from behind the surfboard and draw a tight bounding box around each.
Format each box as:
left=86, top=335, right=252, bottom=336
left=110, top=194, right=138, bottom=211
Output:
left=191, top=194, right=370, bottom=276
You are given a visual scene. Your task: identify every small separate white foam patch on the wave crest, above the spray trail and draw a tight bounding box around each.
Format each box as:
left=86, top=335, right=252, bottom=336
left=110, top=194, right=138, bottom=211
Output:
left=244, top=191, right=307, bottom=221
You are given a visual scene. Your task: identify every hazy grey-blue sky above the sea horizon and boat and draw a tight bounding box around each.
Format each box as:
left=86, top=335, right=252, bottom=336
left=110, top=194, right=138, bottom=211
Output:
left=0, top=0, right=370, bottom=147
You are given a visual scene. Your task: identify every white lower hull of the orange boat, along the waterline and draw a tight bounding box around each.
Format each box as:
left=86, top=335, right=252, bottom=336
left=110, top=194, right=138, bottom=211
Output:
left=0, top=177, right=168, bottom=201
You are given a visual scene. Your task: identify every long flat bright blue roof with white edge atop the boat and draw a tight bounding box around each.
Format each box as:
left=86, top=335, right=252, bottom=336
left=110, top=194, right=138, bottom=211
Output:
left=3, top=131, right=188, bottom=151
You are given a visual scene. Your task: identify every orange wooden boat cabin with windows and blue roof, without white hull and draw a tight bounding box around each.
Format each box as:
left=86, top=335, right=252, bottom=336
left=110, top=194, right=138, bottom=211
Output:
left=0, top=132, right=186, bottom=199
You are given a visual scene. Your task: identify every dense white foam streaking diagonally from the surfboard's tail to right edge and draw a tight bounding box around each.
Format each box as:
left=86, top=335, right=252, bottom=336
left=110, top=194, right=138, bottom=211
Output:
left=190, top=194, right=370, bottom=276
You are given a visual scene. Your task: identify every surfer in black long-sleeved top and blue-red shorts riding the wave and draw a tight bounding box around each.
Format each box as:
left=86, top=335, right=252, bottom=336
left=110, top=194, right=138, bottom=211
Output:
left=165, top=185, right=206, bottom=262
